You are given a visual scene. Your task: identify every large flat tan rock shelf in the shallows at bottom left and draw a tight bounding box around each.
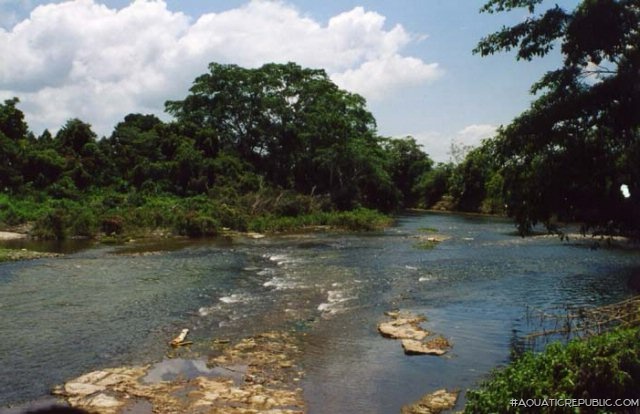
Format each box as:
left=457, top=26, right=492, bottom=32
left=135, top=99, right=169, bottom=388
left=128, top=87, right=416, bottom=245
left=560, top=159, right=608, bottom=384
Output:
left=54, top=332, right=304, bottom=414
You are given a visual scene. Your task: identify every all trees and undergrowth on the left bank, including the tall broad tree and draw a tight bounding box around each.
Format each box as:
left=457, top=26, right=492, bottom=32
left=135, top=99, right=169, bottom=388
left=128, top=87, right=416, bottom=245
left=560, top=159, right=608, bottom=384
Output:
left=0, top=63, right=432, bottom=239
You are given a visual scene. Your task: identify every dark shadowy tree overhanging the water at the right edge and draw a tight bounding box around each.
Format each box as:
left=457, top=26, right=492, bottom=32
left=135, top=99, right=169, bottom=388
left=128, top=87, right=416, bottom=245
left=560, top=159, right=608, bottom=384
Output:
left=475, top=0, right=640, bottom=236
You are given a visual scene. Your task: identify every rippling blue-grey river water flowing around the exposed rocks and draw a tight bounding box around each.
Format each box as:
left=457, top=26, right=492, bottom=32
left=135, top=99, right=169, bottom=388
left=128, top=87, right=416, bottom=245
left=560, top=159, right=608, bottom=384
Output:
left=0, top=214, right=640, bottom=414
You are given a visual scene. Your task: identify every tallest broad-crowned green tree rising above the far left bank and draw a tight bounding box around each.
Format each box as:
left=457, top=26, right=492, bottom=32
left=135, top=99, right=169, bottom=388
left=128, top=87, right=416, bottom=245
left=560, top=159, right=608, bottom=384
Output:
left=166, top=63, right=397, bottom=208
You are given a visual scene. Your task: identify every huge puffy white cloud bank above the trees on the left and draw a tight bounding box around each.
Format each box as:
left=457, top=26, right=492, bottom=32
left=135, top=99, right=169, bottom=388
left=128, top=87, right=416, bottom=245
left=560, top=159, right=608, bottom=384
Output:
left=0, top=0, right=442, bottom=134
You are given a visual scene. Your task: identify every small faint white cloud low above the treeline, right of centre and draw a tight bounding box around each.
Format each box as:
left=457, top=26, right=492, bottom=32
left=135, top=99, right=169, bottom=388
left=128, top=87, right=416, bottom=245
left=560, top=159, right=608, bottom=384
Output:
left=410, top=124, right=498, bottom=162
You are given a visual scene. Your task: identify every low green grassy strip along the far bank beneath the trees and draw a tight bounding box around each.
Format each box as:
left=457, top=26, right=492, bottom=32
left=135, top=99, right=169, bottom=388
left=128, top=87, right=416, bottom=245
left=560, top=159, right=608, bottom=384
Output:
left=0, top=193, right=392, bottom=242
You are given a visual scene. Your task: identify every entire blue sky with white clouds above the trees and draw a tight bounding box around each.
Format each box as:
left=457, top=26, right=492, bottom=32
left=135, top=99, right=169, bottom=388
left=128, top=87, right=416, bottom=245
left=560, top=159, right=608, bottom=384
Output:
left=0, top=0, right=577, bottom=162
